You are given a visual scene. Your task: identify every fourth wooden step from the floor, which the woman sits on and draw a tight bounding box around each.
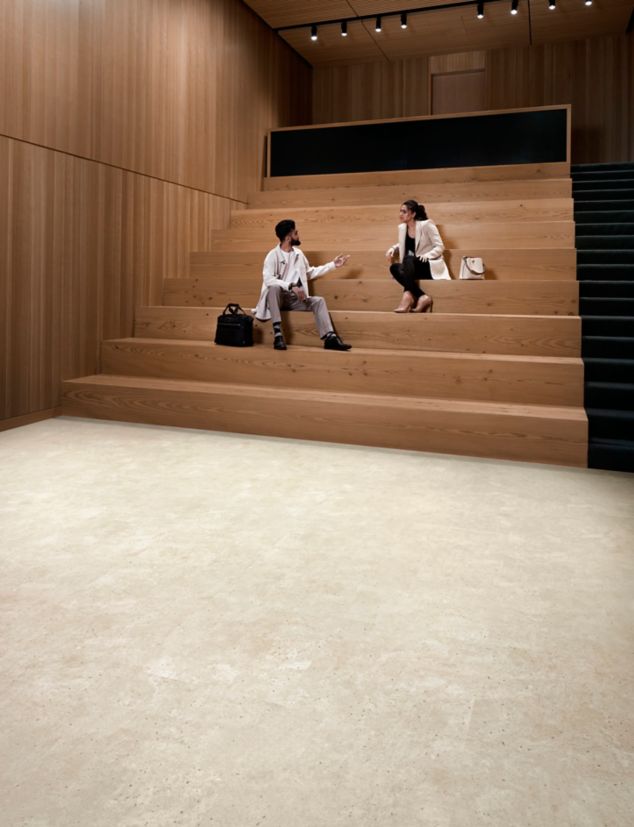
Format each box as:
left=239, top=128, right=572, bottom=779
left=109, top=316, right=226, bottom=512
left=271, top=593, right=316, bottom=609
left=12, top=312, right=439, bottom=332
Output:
left=163, top=278, right=579, bottom=316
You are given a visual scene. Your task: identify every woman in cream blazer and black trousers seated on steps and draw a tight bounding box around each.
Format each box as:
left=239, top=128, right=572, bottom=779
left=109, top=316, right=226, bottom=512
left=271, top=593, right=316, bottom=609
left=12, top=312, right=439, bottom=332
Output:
left=385, top=199, right=451, bottom=313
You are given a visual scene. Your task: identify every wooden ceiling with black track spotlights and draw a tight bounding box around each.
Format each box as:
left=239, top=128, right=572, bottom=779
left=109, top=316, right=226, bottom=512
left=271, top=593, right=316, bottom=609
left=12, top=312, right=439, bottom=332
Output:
left=245, top=0, right=633, bottom=66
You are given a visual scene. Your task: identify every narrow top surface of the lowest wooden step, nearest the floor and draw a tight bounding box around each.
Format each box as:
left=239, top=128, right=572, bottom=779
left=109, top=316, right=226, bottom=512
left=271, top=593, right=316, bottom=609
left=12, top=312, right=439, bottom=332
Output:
left=63, top=374, right=587, bottom=423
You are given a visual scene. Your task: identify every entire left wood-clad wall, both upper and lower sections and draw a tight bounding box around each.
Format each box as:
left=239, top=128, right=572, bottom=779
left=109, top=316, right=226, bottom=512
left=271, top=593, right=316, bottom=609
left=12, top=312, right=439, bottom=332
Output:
left=0, top=0, right=311, bottom=420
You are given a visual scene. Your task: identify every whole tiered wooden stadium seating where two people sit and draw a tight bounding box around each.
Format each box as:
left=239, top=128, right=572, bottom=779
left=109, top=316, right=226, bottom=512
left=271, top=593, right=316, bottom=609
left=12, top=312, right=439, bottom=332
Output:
left=63, top=158, right=587, bottom=466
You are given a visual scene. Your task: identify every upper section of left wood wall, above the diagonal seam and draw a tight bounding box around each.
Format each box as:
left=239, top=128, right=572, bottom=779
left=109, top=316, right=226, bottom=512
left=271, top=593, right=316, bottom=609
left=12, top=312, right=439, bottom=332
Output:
left=0, top=0, right=311, bottom=200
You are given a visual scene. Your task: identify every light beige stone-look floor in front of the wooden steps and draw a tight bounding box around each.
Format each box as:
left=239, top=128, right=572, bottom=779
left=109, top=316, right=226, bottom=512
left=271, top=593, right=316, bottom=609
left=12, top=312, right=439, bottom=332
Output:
left=0, top=419, right=634, bottom=827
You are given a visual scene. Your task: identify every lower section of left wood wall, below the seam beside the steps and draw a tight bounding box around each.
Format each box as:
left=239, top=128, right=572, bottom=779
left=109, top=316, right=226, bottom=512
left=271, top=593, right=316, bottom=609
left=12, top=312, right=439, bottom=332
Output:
left=0, top=138, right=231, bottom=418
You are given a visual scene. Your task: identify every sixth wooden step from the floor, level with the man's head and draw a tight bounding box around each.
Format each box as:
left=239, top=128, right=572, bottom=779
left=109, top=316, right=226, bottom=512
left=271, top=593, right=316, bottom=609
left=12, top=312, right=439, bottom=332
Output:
left=210, top=221, right=575, bottom=255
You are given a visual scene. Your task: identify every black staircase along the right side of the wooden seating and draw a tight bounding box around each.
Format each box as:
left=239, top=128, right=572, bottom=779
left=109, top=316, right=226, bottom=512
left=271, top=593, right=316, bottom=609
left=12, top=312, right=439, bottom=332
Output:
left=572, top=163, right=634, bottom=471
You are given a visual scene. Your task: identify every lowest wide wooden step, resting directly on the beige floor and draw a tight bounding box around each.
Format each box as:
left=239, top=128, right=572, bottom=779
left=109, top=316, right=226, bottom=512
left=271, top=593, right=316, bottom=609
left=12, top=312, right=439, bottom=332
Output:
left=62, top=374, right=587, bottom=466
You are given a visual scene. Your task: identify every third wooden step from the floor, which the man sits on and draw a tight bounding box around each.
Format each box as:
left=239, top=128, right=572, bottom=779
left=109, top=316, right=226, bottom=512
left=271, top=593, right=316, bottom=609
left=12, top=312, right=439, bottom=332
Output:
left=135, top=306, right=581, bottom=357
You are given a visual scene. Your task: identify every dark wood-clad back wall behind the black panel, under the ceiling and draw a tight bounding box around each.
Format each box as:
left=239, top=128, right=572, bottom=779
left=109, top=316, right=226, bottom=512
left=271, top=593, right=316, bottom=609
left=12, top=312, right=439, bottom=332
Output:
left=313, top=34, right=634, bottom=163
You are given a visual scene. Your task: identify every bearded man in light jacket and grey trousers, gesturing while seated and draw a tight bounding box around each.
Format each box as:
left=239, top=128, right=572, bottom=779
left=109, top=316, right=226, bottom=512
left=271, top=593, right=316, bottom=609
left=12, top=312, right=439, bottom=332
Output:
left=253, top=219, right=352, bottom=350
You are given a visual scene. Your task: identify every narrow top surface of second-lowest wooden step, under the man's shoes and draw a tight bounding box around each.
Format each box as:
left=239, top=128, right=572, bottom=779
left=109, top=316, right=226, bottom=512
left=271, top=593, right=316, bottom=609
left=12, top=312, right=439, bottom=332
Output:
left=102, top=338, right=583, bottom=366
